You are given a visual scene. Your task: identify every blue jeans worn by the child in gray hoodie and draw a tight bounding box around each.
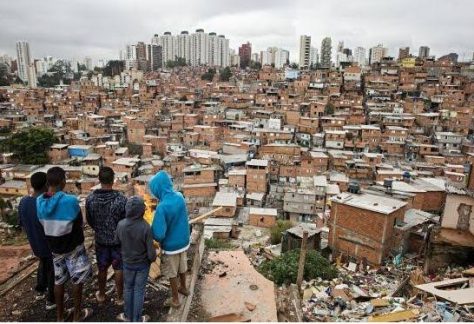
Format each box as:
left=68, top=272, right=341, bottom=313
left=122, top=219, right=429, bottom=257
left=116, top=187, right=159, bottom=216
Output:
left=123, top=263, right=150, bottom=322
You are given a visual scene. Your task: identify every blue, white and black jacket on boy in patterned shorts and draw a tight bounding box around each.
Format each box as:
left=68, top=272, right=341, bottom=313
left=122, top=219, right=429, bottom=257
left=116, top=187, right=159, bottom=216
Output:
left=36, top=191, right=84, bottom=254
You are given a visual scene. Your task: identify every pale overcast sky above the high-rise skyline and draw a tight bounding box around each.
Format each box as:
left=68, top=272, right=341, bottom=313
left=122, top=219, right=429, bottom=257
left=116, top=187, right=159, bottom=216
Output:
left=0, top=0, right=474, bottom=64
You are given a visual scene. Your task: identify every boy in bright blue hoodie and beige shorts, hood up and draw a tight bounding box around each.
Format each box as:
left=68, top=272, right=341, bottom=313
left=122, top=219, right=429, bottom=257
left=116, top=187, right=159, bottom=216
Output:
left=149, top=171, right=190, bottom=307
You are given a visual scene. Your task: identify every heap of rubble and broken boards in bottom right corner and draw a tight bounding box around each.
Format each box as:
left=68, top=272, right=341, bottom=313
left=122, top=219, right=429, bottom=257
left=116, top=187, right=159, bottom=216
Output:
left=302, top=267, right=474, bottom=322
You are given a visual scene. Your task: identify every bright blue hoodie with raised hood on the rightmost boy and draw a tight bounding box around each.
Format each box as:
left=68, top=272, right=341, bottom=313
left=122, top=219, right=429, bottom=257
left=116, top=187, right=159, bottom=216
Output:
left=149, top=171, right=190, bottom=254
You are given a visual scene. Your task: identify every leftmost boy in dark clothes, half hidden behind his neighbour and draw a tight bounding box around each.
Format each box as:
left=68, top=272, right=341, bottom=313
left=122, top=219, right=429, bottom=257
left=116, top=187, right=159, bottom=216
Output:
left=18, top=172, right=56, bottom=310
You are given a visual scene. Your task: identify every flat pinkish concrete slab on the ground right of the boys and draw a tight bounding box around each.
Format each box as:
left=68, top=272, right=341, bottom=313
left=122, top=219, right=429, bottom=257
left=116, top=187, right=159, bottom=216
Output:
left=201, top=250, right=278, bottom=322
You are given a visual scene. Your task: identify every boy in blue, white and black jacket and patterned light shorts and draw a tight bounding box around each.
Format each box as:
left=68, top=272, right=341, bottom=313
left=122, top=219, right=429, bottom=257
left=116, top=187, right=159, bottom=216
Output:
left=36, top=167, right=92, bottom=322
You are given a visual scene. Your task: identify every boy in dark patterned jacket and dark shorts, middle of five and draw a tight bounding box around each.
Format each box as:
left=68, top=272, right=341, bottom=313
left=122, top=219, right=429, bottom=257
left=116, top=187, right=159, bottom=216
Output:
left=86, top=167, right=127, bottom=306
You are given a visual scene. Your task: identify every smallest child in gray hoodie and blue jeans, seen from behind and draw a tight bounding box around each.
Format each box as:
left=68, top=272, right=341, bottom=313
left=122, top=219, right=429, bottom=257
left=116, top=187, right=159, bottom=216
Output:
left=117, top=196, right=156, bottom=322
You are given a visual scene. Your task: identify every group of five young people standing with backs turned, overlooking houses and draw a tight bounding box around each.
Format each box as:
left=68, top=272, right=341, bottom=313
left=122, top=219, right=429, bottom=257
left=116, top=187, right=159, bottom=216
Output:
left=18, top=167, right=190, bottom=322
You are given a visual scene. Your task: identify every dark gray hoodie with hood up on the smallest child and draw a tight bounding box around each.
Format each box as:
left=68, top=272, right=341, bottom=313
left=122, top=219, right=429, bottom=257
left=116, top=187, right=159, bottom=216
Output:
left=117, top=196, right=156, bottom=264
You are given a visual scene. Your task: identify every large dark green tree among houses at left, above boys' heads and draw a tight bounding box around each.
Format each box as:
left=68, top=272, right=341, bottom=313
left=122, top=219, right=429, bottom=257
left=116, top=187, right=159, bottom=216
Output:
left=6, top=127, right=57, bottom=164
